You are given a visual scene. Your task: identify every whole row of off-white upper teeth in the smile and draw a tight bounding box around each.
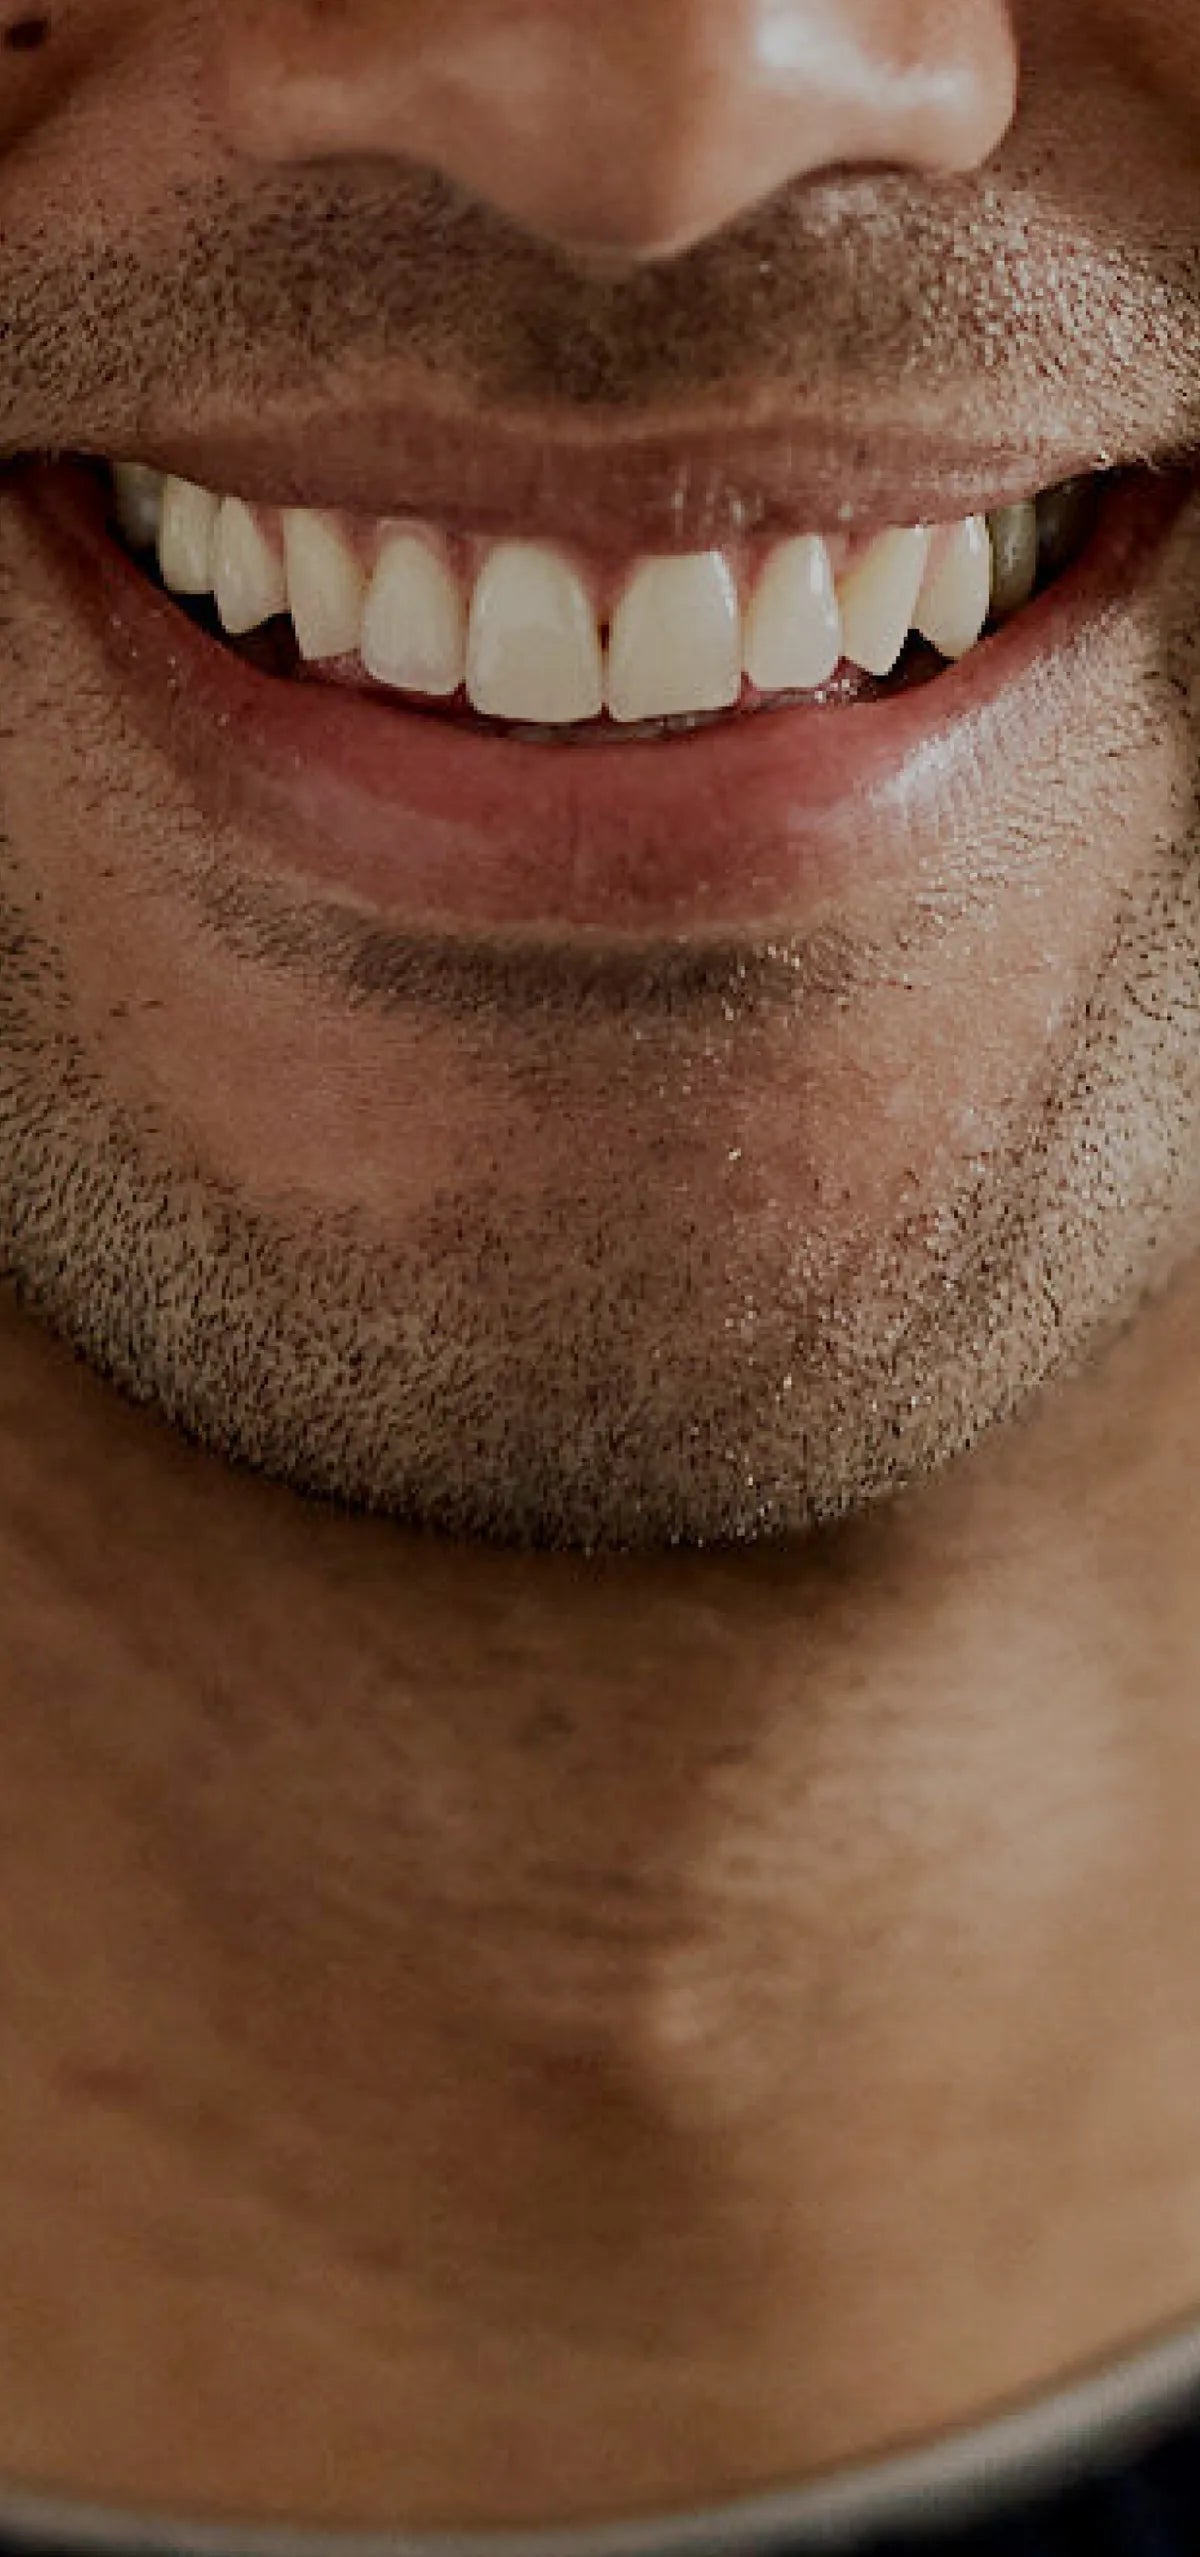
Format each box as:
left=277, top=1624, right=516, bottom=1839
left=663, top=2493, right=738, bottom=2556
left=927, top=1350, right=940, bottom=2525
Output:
left=115, top=463, right=1039, bottom=726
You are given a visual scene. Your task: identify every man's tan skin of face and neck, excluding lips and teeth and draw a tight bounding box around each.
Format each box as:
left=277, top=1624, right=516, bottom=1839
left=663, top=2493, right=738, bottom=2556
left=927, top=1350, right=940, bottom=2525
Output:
left=0, top=0, right=1200, bottom=2524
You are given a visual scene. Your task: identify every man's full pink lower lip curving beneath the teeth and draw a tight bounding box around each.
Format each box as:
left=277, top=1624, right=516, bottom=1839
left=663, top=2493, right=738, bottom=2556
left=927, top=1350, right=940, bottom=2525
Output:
left=10, top=463, right=1195, bottom=936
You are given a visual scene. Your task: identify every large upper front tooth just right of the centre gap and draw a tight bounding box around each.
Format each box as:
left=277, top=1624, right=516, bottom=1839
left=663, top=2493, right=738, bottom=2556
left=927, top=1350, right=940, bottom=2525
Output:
left=609, top=550, right=742, bottom=721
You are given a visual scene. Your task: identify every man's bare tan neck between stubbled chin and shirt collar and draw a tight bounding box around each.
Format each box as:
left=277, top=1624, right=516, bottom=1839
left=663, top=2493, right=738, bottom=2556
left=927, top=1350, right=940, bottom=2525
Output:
left=0, top=1273, right=1200, bottom=2529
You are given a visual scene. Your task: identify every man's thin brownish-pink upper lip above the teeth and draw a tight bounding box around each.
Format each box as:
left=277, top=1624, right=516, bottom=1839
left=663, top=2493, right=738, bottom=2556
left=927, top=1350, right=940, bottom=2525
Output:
left=77, top=401, right=1187, bottom=555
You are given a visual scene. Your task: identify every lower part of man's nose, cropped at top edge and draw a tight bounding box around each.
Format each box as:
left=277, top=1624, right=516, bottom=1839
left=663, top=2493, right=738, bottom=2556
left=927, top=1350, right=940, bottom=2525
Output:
left=220, top=0, right=1016, bottom=258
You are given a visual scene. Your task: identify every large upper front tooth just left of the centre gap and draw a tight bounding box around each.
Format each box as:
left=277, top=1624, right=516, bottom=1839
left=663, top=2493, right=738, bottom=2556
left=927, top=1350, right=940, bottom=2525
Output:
left=466, top=542, right=604, bottom=726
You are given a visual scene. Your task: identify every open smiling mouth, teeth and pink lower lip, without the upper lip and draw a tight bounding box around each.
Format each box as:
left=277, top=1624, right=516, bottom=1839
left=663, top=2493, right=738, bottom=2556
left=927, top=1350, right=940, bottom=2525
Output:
left=18, top=455, right=1197, bottom=941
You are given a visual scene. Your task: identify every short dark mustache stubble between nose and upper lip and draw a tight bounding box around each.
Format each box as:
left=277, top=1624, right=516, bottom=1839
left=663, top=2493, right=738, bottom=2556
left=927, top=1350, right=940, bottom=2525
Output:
left=0, top=130, right=1200, bottom=460
